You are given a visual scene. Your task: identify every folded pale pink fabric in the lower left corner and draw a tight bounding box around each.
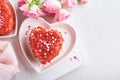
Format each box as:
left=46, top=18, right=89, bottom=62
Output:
left=0, top=41, right=19, bottom=80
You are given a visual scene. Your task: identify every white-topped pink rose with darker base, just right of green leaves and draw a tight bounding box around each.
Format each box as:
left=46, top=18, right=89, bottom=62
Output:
left=42, top=0, right=61, bottom=16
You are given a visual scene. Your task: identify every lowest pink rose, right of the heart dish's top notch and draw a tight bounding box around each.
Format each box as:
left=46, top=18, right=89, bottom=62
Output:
left=54, top=9, right=70, bottom=22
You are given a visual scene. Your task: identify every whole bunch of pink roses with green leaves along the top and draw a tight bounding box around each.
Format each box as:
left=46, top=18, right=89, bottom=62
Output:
left=18, top=0, right=87, bottom=21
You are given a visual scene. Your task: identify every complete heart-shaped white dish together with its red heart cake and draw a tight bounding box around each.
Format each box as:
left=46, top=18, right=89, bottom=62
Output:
left=19, top=18, right=76, bottom=73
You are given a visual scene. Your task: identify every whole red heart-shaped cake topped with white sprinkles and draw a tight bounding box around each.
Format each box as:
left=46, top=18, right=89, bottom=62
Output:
left=29, top=27, right=64, bottom=64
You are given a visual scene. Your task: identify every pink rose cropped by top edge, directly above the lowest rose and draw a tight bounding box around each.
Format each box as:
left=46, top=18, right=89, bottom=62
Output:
left=61, top=0, right=77, bottom=8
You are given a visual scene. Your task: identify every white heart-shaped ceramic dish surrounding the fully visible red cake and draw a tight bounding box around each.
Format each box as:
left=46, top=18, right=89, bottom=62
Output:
left=19, top=18, right=76, bottom=73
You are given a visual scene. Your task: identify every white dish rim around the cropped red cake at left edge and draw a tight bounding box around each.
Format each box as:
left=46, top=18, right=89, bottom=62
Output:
left=0, top=0, right=18, bottom=38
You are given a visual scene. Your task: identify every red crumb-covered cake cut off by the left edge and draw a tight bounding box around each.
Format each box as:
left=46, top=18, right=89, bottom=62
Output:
left=0, top=0, right=15, bottom=35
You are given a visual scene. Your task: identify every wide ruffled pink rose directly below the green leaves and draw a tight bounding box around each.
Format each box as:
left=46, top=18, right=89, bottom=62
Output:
left=19, top=4, right=44, bottom=18
